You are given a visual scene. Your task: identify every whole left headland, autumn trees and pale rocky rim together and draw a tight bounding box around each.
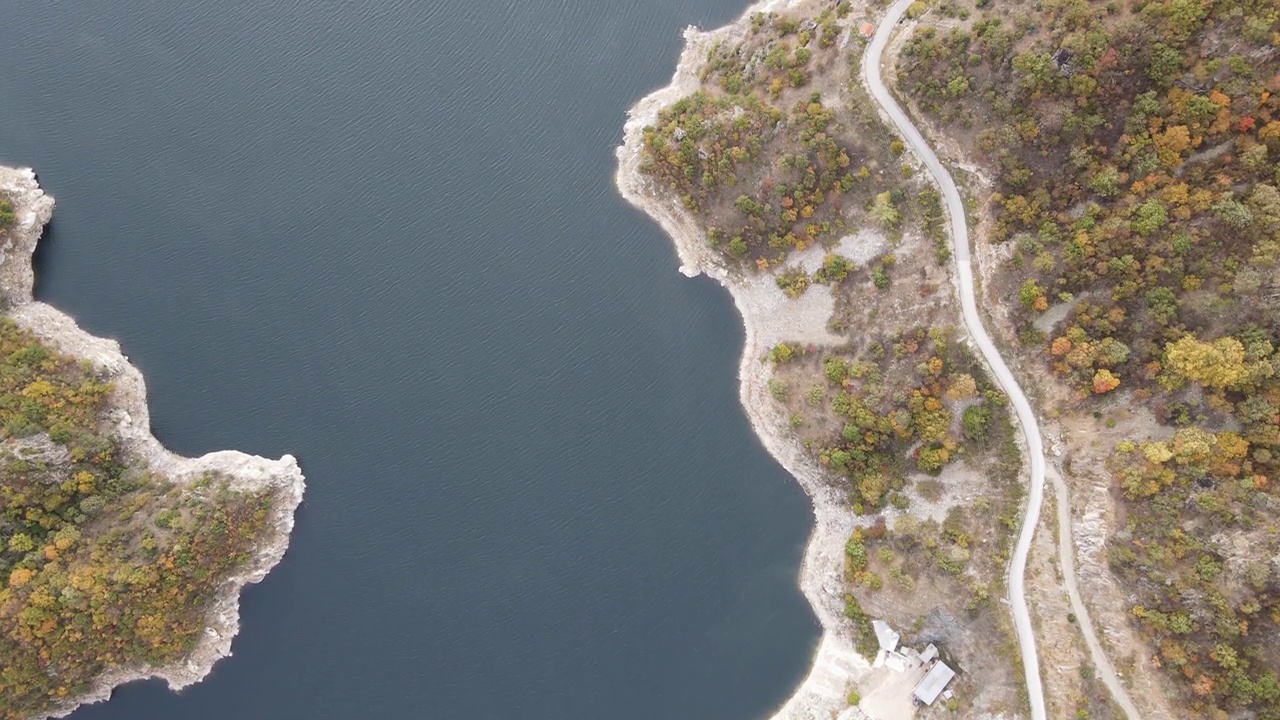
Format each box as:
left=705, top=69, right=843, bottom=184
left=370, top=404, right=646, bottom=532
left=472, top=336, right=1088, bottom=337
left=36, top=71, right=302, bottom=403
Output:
left=0, top=168, right=305, bottom=720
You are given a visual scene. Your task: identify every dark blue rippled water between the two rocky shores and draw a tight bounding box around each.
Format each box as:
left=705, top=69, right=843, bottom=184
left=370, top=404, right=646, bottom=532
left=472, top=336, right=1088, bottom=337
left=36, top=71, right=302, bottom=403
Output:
left=0, top=0, right=818, bottom=720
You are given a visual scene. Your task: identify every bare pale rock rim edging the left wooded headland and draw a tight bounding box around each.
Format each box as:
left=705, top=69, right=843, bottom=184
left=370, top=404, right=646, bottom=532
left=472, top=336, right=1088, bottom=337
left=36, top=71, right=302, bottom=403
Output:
left=0, top=168, right=306, bottom=717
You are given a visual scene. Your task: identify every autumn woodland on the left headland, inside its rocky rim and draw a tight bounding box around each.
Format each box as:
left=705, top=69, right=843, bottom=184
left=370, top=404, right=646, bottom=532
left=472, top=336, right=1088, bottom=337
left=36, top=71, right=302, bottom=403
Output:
left=0, top=311, right=271, bottom=720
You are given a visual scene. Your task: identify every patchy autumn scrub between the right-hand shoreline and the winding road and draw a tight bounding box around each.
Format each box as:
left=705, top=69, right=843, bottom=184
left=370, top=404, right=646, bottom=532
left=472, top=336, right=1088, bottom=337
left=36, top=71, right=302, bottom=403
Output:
left=641, top=3, right=1021, bottom=707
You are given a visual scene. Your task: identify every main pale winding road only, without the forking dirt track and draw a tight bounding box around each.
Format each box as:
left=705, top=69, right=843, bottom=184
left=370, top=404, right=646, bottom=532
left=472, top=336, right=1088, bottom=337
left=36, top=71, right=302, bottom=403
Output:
left=863, top=0, right=1046, bottom=720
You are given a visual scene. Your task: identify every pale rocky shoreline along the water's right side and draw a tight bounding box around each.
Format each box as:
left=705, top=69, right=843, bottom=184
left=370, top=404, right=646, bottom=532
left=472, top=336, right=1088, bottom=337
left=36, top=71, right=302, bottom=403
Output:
left=616, top=0, right=870, bottom=720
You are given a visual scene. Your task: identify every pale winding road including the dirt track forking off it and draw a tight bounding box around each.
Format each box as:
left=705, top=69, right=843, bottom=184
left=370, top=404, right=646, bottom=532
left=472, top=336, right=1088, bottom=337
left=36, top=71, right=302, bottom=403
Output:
left=863, top=0, right=1139, bottom=720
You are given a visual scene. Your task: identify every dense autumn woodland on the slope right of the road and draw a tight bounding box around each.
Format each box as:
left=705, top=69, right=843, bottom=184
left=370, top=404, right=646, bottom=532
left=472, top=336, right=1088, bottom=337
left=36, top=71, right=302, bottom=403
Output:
left=899, top=0, right=1280, bottom=719
